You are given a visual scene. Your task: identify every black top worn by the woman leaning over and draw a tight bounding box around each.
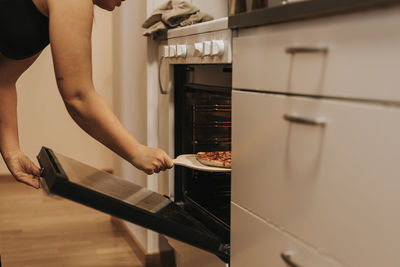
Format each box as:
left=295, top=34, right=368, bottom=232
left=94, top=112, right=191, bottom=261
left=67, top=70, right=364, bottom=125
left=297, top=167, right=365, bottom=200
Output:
left=0, top=0, right=50, bottom=59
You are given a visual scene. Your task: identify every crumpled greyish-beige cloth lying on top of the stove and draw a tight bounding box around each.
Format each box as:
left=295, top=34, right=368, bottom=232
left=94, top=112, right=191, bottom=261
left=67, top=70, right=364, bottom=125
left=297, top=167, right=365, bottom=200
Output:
left=142, top=0, right=213, bottom=36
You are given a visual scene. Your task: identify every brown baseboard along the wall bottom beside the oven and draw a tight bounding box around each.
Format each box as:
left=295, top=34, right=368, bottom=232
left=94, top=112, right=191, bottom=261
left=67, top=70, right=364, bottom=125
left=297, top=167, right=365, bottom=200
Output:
left=111, top=217, right=176, bottom=267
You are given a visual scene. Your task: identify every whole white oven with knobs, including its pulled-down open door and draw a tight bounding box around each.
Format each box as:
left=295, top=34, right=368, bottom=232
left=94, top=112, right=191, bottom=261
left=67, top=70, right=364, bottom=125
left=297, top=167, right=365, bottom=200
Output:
left=38, top=18, right=232, bottom=266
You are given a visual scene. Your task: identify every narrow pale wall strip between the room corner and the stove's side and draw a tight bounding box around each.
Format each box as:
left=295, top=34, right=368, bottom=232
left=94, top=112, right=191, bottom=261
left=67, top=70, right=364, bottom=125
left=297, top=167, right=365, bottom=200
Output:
left=113, top=1, right=148, bottom=252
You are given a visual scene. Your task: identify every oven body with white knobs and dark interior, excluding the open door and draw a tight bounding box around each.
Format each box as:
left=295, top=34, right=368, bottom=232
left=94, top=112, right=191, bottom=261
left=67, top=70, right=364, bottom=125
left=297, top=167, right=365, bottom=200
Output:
left=158, top=18, right=233, bottom=267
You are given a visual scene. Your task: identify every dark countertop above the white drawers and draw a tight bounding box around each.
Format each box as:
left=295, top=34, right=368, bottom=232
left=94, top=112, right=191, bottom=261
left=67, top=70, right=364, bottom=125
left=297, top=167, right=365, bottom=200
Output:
left=228, top=0, right=400, bottom=29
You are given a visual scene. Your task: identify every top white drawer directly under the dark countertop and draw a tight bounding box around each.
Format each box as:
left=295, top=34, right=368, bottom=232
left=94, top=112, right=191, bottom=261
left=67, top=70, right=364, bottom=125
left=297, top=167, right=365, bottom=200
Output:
left=233, top=6, right=400, bottom=101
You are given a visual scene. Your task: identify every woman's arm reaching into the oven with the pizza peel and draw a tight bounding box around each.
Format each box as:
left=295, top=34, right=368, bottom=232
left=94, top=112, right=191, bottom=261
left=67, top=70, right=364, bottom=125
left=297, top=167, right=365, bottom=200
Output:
left=48, top=0, right=173, bottom=174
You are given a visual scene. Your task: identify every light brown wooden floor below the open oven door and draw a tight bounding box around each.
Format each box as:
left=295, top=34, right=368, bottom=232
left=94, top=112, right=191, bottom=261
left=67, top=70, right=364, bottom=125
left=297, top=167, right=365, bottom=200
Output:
left=0, top=176, right=142, bottom=267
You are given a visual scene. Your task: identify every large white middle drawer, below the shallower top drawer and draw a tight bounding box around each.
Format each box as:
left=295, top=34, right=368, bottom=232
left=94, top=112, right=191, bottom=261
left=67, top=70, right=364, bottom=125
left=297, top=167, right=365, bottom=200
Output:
left=232, top=90, right=400, bottom=267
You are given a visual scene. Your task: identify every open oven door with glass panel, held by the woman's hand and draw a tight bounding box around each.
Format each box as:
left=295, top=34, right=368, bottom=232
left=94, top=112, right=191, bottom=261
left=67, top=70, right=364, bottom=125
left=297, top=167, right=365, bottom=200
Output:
left=38, top=147, right=230, bottom=262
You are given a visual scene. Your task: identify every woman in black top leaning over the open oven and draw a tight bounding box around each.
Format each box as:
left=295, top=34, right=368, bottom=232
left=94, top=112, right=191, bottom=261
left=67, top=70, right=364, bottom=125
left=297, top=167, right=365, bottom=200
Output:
left=0, top=0, right=173, bottom=188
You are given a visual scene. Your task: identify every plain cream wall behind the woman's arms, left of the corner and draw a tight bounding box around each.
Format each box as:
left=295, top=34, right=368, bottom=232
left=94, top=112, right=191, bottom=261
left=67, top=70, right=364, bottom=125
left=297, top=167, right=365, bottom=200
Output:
left=0, top=8, right=113, bottom=174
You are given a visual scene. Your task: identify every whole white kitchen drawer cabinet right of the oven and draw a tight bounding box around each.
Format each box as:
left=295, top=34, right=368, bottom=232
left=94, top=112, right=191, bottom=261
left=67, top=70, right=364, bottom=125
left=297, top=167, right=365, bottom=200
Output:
left=231, top=4, right=400, bottom=267
